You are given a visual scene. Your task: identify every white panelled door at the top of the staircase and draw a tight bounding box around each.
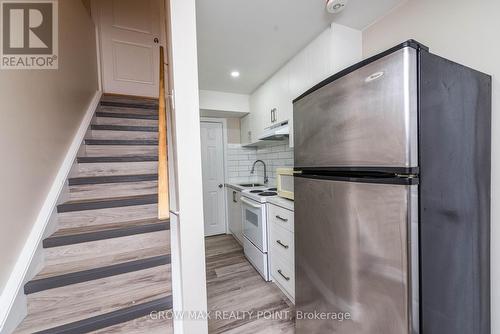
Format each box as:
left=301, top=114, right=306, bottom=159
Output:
left=95, top=0, right=162, bottom=97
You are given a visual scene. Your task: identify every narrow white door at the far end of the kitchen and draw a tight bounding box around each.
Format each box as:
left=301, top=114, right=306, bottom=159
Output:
left=201, top=122, right=226, bottom=236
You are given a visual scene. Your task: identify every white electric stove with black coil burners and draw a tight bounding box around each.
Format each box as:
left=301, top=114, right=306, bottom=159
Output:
left=240, top=187, right=278, bottom=281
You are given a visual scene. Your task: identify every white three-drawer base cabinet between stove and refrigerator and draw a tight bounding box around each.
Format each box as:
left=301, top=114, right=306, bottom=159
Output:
left=267, top=203, right=295, bottom=303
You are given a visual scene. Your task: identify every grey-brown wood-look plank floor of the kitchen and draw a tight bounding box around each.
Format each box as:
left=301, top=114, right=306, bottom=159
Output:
left=205, top=235, right=294, bottom=334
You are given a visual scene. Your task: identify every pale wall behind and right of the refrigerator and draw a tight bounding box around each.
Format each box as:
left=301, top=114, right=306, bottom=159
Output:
left=363, top=0, right=500, bottom=334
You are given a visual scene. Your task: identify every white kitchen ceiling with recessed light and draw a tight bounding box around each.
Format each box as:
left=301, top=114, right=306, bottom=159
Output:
left=196, top=0, right=404, bottom=94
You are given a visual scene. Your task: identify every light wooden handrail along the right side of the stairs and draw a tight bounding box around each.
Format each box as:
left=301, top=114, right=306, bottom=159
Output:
left=158, top=46, right=170, bottom=219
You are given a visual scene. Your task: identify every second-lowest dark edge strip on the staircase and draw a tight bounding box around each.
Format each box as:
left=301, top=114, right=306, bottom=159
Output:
left=24, top=255, right=171, bottom=295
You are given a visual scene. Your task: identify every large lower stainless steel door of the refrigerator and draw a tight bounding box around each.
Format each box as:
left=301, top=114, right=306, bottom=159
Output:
left=295, top=177, right=419, bottom=334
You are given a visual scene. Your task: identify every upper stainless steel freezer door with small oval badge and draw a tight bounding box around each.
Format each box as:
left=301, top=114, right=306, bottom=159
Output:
left=293, top=47, right=418, bottom=168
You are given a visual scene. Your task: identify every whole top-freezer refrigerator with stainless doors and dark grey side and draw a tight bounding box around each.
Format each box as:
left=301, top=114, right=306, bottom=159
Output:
left=294, top=40, right=491, bottom=334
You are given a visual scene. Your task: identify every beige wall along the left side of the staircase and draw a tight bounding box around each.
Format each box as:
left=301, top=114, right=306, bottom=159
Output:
left=0, top=0, right=98, bottom=328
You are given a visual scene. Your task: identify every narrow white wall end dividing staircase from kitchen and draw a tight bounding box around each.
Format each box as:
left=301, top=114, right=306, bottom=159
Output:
left=168, top=0, right=208, bottom=334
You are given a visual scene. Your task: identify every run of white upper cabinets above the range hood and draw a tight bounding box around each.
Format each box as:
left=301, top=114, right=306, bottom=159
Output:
left=241, top=24, right=362, bottom=147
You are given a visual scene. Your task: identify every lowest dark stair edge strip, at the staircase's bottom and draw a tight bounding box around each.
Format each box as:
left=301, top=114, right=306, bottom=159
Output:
left=36, top=296, right=172, bottom=334
